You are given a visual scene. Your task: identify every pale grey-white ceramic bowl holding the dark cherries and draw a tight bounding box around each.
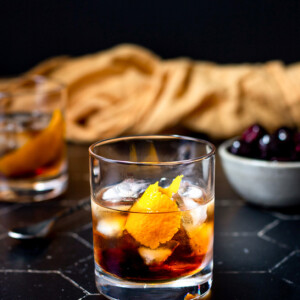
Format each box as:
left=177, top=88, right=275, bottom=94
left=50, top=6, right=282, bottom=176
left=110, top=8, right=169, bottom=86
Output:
left=219, top=139, right=300, bottom=207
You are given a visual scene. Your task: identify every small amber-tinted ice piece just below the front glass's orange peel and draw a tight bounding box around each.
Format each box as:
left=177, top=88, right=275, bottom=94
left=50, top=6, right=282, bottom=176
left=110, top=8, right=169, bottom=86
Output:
left=138, top=241, right=179, bottom=265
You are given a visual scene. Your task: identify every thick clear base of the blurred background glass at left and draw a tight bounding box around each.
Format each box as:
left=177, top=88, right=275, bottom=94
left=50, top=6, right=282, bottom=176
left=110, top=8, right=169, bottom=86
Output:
left=0, top=171, right=68, bottom=203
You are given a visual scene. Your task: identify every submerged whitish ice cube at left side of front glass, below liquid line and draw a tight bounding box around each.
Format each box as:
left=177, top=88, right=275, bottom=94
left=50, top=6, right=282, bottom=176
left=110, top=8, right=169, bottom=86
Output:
left=96, top=213, right=127, bottom=237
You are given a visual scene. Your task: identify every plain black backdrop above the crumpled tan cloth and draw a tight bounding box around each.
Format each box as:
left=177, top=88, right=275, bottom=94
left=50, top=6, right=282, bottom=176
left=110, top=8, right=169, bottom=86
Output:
left=0, top=0, right=300, bottom=76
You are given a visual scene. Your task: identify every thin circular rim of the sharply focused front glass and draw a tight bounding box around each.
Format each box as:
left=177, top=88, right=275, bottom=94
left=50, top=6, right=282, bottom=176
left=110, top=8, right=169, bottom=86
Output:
left=89, top=135, right=216, bottom=166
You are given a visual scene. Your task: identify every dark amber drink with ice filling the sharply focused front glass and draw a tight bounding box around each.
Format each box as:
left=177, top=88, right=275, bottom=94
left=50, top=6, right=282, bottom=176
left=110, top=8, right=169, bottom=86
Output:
left=92, top=180, right=214, bottom=283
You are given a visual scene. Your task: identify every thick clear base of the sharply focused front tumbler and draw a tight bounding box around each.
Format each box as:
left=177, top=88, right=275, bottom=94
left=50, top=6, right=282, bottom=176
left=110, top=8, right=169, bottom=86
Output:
left=95, top=262, right=213, bottom=300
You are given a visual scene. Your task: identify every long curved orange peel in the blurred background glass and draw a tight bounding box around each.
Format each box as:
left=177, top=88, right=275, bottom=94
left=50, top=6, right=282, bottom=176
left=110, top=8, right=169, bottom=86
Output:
left=0, top=109, right=65, bottom=176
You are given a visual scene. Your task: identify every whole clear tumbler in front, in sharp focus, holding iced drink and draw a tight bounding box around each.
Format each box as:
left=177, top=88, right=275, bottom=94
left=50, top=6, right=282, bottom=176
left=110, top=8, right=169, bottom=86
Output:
left=89, top=136, right=215, bottom=300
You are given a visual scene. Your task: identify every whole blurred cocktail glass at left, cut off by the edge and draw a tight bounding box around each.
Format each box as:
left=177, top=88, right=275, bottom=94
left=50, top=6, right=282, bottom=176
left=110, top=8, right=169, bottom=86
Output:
left=0, top=76, right=68, bottom=202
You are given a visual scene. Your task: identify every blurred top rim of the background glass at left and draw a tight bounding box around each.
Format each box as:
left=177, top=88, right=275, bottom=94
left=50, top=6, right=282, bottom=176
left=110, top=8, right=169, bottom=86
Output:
left=0, top=74, right=66, bottom=99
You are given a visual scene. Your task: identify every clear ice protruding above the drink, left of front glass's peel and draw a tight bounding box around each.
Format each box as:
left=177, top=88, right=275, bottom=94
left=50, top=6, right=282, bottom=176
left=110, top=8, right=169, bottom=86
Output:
left=102, top=179, right=149, bottom=201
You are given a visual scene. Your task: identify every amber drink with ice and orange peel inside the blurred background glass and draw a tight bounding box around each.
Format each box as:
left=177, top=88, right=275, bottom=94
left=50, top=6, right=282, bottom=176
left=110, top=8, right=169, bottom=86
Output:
left=0, top=110, right=65, bottom=179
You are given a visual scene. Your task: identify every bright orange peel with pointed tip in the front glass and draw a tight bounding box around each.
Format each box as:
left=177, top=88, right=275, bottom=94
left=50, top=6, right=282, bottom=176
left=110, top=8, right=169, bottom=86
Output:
left=125, top=176, right=183, bottom=249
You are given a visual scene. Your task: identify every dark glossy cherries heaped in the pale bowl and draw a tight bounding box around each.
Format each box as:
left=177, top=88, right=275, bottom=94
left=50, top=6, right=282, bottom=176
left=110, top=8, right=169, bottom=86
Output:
left=229, top=124, right=300, bottom=161
